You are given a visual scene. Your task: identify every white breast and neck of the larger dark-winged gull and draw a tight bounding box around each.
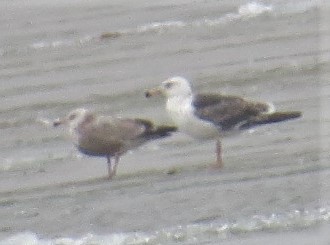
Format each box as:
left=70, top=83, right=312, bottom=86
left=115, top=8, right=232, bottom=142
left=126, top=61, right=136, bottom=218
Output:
left=166, top=97, right=219, bottom=139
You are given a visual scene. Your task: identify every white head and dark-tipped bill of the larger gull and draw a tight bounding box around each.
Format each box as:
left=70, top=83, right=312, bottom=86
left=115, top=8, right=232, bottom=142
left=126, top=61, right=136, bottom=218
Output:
left=145, top=77, right=192, bottom=98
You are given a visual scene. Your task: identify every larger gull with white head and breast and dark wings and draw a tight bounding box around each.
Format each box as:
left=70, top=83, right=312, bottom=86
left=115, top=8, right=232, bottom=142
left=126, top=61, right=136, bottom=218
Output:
left=145, top=77, right=301, bottom=168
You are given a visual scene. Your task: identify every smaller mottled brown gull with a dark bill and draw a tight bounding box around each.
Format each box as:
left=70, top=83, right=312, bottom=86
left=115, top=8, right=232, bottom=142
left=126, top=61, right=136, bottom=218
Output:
left=53, top=108, right=176, bottom=179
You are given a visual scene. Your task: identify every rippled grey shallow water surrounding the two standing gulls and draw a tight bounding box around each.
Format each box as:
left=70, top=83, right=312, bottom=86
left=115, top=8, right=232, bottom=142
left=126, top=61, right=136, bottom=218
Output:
left=0, top=0, right=330, bottom=244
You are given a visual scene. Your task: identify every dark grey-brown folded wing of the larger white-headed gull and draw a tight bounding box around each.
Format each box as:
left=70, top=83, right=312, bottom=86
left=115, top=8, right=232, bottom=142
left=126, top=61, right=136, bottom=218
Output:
left=193, top=94, right=269, bottom=130
